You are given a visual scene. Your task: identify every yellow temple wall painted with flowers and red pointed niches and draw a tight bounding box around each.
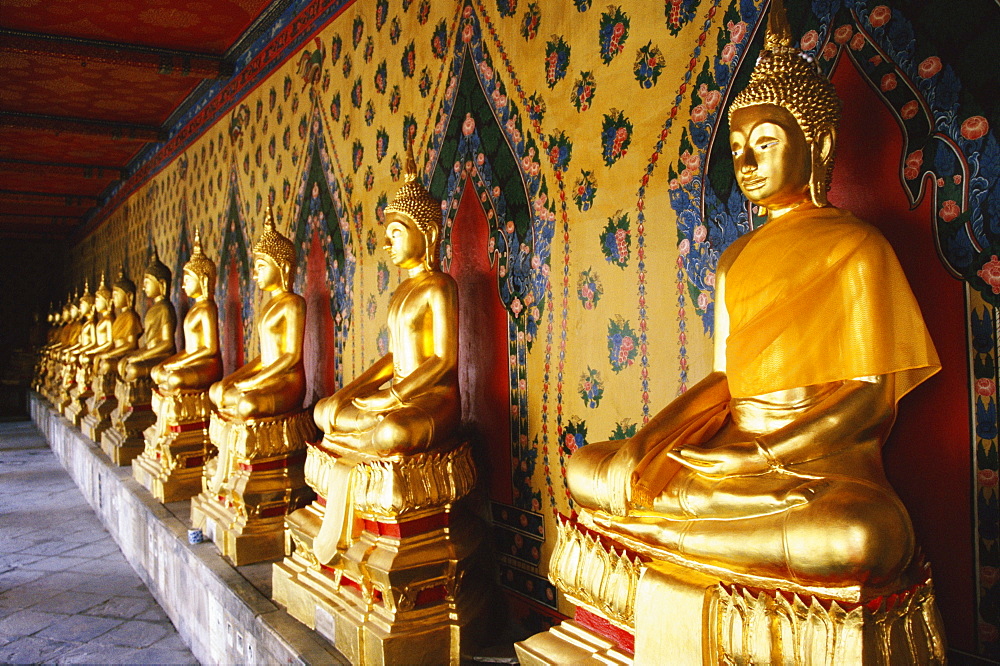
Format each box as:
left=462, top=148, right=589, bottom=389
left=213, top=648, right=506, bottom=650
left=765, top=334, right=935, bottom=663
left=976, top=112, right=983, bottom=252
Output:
left=62, top=0, right=1000, bottom=652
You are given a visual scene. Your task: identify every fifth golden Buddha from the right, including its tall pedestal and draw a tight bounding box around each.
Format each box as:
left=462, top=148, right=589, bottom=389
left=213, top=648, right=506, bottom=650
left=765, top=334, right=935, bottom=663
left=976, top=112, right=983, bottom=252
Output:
left=101, top=252, right=177, bottom=465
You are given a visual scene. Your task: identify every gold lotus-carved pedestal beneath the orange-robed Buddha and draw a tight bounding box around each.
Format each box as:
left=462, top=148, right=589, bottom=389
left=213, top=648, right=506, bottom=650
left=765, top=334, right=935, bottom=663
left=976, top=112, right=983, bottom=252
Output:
left=515, top=512, right=946, bottom=666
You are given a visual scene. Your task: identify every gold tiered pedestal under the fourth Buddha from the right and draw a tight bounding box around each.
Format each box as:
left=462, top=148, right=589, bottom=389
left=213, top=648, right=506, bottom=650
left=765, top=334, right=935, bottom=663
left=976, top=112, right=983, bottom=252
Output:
left=132, top=388, right=215, bottom=503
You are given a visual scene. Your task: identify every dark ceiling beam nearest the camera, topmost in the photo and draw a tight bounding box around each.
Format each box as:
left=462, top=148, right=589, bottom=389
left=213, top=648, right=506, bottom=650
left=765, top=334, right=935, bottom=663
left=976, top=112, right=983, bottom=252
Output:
left=0, top=29, right=233, bottom=79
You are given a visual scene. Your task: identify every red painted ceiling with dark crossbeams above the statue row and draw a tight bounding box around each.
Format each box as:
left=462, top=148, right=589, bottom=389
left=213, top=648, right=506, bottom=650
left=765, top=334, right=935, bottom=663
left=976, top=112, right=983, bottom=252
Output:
left=0, top=0, right=278, bottom=239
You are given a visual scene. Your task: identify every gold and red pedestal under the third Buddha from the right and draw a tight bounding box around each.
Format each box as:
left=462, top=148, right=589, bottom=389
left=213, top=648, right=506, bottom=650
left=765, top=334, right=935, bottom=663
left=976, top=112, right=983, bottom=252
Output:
left=191, top=410, right=316, bottom=566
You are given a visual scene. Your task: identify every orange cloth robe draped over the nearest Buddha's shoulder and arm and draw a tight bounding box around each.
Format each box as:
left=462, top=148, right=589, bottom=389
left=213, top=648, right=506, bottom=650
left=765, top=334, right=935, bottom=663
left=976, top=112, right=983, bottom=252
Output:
left=631, top=207, right=941, bottom=507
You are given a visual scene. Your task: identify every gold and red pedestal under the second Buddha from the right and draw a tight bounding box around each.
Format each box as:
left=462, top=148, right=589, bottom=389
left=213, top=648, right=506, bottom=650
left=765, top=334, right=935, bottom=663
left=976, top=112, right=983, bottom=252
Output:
left=272, top=441, right=492, bottom=664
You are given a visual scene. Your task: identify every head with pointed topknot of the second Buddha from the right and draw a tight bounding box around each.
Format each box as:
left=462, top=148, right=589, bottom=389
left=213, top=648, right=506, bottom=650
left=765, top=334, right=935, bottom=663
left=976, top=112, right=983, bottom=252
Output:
left=384, top=148, right=441, bottom=271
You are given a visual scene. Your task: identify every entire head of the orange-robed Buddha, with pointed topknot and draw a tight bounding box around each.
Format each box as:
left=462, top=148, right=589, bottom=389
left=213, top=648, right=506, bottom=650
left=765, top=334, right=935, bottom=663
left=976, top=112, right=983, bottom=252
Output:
left=729, top=0, right=840, bottom=208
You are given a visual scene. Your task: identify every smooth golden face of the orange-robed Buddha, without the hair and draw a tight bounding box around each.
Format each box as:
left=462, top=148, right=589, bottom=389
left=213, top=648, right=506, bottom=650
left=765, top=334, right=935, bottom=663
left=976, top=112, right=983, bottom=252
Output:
left=729, top=104, right=812, bottom=210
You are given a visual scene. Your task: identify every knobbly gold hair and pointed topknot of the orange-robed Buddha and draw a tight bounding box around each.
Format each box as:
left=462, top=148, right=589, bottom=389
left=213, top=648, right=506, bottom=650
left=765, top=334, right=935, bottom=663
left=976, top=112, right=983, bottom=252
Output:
left=729, top=0, right=841, bottom=143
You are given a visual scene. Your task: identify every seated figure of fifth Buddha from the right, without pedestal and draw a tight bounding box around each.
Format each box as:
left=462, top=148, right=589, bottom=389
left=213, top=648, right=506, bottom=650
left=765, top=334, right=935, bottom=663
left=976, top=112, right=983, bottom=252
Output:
left=118, top=246, right=177, bottom=382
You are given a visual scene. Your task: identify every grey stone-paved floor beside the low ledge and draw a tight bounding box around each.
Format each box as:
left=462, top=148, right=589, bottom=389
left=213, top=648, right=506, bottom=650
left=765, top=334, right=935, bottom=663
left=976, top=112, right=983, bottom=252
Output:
left=0, top=421, right=198, bottom=664
